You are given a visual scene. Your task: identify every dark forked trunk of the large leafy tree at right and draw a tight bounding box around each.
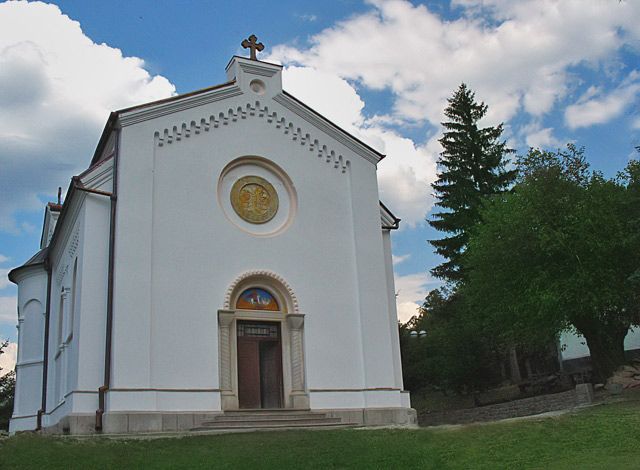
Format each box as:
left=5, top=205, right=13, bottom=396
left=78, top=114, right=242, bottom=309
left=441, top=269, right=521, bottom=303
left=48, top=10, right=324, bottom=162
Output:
left=576, top=323, right=629, bottom=383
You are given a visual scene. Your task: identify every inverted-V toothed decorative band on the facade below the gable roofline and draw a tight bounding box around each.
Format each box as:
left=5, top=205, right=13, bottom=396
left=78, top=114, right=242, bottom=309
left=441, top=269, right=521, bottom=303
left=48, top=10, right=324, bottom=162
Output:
left=154, top=101, right=349, bottom=173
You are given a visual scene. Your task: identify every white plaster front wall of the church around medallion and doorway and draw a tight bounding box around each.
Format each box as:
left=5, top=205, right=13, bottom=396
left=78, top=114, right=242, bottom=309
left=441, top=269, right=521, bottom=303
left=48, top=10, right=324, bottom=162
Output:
left=111, top=59, right=399, bottom=409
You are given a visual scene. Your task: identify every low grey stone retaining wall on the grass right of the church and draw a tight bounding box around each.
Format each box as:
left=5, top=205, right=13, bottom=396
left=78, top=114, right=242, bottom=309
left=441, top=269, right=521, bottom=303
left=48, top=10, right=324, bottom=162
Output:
left=418, top=390, right=578, bottom=426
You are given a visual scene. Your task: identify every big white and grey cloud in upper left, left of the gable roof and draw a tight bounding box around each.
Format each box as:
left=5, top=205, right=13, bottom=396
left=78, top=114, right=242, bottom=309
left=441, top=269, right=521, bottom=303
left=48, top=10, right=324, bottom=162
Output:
left=0, top=1, right=175, bottom=233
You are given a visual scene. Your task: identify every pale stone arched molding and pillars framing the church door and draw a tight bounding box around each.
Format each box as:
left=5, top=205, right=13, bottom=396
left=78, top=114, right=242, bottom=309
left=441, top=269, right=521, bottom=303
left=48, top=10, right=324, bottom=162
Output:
left=218, top=270, right=309, bottom=410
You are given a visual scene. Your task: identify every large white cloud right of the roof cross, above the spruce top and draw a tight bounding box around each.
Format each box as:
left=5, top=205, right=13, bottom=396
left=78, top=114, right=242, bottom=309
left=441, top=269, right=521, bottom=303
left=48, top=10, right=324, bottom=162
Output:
left=268, top=0, right=640, bottom=228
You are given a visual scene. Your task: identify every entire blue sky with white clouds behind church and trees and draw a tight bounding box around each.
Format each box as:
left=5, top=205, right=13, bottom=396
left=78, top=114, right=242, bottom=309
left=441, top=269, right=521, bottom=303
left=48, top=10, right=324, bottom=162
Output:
left=0, top=0, right=640, bottom=368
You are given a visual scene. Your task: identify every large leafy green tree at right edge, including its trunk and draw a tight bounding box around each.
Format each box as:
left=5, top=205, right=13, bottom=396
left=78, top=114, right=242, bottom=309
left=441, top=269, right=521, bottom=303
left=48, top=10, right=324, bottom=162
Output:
left=463, top=145, right=640, bottom=381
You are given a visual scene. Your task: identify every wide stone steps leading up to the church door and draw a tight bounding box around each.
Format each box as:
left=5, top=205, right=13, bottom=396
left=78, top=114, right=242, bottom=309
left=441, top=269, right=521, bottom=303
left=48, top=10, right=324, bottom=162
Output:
left=192, top=410, right=357, bottom=431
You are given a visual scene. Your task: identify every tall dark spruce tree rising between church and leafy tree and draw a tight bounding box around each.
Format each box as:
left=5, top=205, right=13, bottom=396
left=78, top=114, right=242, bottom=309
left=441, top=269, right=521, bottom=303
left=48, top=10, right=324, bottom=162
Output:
left=429, top=83, right=516, bottom=284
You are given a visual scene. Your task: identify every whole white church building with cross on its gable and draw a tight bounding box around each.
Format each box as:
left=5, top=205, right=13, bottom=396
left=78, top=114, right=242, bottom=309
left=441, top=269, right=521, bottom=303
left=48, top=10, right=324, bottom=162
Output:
left=10, top=38, right=415, bottom=434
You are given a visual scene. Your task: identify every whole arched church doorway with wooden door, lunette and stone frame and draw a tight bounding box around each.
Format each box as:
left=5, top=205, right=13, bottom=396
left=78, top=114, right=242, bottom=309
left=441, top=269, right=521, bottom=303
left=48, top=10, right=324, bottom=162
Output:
left=218, top=271, right=309, bottom=410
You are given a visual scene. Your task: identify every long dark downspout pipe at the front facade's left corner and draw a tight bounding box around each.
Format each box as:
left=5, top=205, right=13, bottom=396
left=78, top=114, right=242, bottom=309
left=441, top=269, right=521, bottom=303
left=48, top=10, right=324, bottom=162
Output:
left=95, top=129, right=120, bottom=431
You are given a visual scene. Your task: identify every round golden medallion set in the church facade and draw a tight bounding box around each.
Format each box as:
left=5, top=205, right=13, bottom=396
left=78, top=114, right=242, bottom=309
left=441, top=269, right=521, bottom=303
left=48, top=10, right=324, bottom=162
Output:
left=231, top=176, right=278, bottom=224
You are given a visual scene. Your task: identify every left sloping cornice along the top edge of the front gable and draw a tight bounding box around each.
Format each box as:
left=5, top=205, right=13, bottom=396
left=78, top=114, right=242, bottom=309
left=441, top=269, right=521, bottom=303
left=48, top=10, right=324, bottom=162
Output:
left=119, top=84, right=242, bottom=127
